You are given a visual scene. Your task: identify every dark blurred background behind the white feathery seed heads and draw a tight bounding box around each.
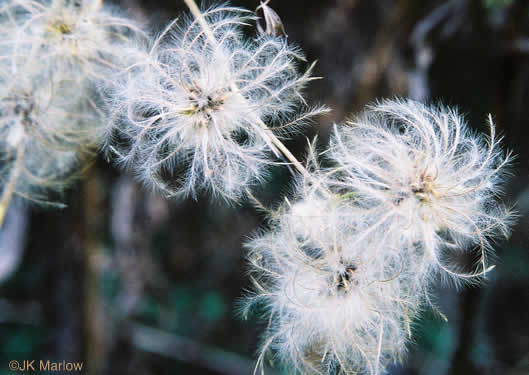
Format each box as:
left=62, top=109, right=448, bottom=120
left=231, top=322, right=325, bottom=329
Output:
left=0, top=0, right=529, bottom=375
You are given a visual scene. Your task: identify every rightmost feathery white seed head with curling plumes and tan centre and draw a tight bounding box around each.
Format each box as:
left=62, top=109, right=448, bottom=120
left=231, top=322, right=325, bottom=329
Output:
left=329, top=101, right=510, bottom=284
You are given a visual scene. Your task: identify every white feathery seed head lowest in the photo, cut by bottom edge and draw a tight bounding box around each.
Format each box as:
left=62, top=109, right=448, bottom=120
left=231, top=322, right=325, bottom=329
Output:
left=243, top=199, right=416, bottom=374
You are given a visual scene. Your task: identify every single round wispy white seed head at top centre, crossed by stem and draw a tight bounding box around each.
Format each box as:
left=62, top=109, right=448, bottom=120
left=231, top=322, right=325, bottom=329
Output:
left=106, top=7, right=322, bottom=201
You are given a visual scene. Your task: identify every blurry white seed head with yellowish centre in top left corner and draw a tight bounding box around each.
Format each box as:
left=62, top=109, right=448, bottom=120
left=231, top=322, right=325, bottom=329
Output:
left=4, top=0, right=142, bottom=80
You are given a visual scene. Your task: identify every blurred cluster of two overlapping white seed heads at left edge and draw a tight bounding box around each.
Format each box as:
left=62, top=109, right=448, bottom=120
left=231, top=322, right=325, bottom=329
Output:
left=0, top=0, right=141, bottom=209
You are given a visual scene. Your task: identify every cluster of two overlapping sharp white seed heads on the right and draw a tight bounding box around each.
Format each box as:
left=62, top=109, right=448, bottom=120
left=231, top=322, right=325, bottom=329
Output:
left=246, top=101, right=509, bottom=374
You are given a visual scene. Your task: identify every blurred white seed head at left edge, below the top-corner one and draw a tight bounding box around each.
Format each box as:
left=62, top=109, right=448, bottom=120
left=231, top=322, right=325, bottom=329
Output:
left=0, top=64, right=99, bottom=207
